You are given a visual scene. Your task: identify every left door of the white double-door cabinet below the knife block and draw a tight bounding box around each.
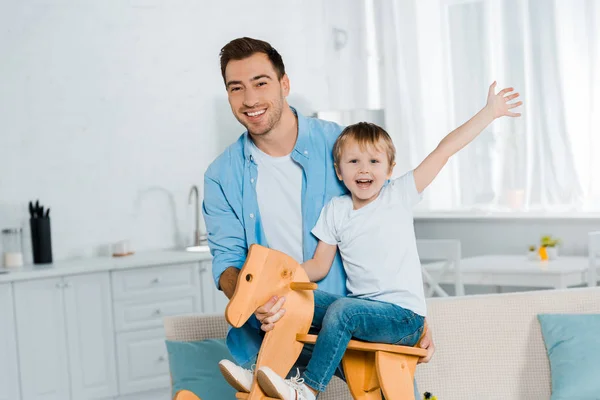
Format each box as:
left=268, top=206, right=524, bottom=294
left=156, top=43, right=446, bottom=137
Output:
left=14, top=278, right=70, bottom=400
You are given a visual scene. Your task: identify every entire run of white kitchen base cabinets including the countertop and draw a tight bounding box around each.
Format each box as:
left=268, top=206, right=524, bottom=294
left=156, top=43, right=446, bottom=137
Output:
left=0, top=250, right=212, bottom=400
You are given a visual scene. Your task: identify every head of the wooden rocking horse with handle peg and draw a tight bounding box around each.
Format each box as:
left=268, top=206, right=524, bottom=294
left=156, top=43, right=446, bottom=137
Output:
left=225, top=244, right=316, bottom=328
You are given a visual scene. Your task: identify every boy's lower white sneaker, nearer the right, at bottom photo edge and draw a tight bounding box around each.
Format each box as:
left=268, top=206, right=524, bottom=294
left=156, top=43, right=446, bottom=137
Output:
left=256, top=367, right=316, bottom=400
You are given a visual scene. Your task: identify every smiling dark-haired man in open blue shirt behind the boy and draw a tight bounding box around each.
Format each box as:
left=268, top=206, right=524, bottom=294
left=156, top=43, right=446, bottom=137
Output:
left=203, top=38, right=434, bottom=391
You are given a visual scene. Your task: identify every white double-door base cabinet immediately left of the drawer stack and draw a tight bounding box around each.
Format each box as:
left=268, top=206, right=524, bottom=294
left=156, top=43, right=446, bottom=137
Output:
left=14, top=272, right=117, bottom=400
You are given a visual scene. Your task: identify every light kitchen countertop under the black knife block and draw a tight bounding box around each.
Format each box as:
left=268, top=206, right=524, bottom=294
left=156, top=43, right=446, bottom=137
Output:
left=0, top=250, right=212, bottom=283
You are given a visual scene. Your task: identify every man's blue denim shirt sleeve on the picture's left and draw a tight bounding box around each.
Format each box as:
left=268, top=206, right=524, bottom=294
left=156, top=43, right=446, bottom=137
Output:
left=202, top=174, right=248, bottom=289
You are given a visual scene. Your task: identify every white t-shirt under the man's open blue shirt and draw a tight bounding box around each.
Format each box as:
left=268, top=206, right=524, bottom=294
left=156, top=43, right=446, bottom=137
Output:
left=250, top=143, right=304, bottom=263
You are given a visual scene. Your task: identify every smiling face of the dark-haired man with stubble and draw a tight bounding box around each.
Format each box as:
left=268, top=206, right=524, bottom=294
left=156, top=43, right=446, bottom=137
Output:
left=225, top=53, right=290, bottom=135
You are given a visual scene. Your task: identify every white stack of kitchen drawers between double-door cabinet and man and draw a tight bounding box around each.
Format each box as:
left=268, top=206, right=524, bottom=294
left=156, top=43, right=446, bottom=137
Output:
left=111, top=263, right=203, bottom=395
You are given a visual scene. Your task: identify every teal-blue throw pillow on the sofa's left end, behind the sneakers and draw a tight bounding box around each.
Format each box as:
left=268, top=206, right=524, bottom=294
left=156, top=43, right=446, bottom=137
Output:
left=166, top=339, right=236, bottom=400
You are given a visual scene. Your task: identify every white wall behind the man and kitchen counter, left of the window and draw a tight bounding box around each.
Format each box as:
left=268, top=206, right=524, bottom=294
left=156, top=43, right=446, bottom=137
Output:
left=0, top=0, right=330, bottom=260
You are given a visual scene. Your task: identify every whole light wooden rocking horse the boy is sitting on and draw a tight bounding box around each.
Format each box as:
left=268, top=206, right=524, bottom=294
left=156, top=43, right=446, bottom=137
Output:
left=176, top=244, right=427, bottom=400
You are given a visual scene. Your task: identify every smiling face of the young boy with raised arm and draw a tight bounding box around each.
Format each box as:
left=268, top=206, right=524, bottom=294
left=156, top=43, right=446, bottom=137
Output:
left=336, top=139, right=393, bottom=209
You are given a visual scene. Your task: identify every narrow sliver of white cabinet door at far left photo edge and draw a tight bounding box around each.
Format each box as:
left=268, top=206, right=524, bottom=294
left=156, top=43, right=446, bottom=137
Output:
left=0, top=283, right=20, bottom=400
